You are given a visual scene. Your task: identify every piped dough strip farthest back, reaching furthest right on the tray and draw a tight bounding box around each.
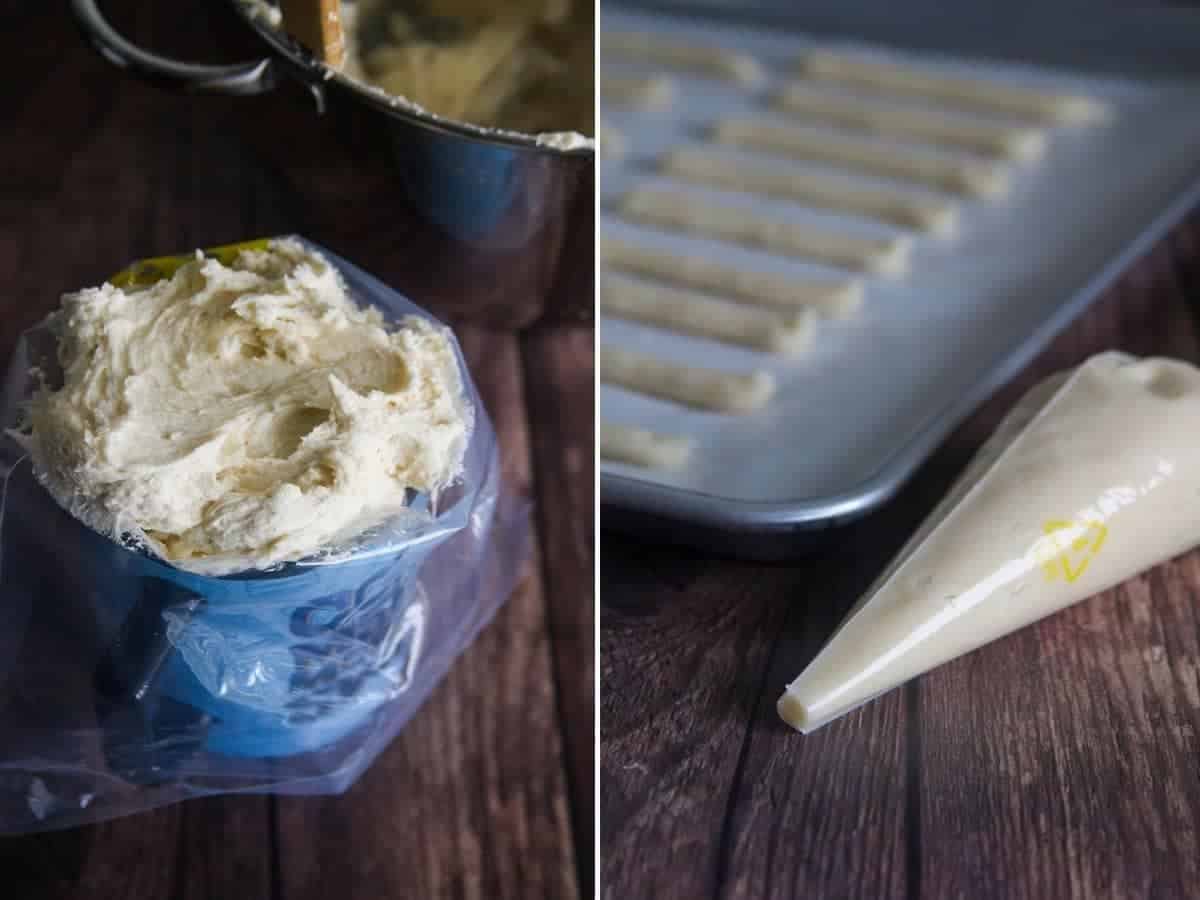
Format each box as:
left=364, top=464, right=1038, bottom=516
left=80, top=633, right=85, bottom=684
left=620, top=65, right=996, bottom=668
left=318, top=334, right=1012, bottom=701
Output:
left=799, top=50, right=1109, bottom=125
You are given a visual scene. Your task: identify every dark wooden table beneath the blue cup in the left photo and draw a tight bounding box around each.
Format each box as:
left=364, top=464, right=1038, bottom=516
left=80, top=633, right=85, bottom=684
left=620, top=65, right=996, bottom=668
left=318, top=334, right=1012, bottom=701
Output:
left=0, top=0, right=595, bottom=900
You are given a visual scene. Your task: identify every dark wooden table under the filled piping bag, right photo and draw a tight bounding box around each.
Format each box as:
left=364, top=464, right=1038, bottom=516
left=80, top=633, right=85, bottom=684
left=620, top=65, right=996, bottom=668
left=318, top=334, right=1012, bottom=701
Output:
left=600, top=170, right=1200, bottom=900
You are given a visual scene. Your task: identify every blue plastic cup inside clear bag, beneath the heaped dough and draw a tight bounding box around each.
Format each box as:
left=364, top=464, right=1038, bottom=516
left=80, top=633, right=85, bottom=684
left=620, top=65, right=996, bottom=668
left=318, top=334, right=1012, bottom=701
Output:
left=56, top=480, right=434, bottom=757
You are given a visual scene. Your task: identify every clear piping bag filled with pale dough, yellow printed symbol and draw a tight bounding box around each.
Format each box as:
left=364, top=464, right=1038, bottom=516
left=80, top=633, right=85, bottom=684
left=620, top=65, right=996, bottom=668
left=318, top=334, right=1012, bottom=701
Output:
left=778, top=353, right=1200, bottom=733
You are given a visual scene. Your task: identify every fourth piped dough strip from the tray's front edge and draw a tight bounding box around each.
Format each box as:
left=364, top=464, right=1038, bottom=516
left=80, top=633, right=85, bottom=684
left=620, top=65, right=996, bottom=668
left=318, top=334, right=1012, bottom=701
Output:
left=600, top=235, right=863, bottom=318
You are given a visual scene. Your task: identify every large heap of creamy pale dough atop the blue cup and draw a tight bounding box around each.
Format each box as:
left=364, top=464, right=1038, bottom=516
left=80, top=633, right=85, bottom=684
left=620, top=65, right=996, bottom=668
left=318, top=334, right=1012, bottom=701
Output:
left=25, top=240, right=473, bottom=575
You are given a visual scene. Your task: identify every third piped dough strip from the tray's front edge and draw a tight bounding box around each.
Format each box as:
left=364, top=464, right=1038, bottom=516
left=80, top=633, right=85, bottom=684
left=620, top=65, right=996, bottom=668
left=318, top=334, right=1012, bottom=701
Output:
left=600, top=272, right=818, bottom=354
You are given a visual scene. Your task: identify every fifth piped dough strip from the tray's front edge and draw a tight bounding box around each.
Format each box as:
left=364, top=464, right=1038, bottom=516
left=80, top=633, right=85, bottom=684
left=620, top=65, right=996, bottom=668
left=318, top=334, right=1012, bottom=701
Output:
left=618, top=187, right=911, bottom=275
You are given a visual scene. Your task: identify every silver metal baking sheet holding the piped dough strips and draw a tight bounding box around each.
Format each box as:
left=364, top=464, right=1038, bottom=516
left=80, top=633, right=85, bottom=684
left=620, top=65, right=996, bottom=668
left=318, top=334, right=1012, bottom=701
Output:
left=601, top=6, right=1200, bottom=528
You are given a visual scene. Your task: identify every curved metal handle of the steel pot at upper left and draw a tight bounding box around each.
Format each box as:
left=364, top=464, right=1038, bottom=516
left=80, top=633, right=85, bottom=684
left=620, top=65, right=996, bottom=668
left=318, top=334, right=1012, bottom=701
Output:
left=71, top=0, right=277, bottom=94
